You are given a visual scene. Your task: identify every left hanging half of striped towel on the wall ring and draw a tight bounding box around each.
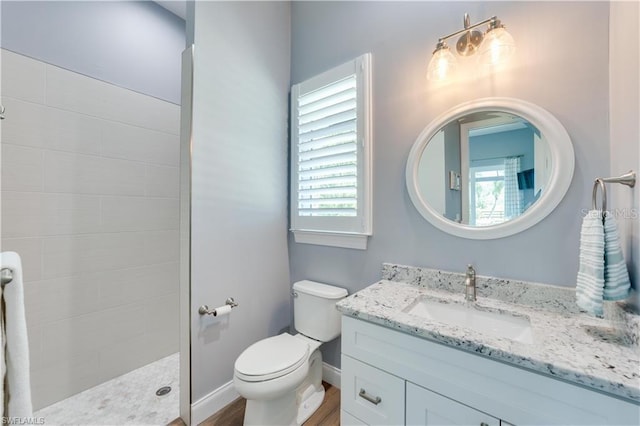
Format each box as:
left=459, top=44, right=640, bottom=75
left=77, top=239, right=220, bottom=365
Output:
left=576, top=210, right=604, bottom=316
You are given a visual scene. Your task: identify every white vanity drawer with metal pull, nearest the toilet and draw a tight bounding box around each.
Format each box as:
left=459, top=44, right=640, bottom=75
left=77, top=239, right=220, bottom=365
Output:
left=340, top=355, right=404, bottom=425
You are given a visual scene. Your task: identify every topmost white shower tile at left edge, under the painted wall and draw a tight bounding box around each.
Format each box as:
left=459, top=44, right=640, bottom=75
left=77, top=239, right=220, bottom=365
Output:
left=0, top=49, right=45, bottom=103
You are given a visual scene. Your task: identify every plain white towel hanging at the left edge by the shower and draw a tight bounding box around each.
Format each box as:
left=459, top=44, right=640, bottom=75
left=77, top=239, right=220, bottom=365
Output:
left=0, top=252, right=33, bottom=417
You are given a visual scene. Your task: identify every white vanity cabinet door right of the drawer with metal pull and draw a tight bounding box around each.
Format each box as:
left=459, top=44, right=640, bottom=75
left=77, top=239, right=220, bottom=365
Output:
left=406, top=382, right=500, bottom=426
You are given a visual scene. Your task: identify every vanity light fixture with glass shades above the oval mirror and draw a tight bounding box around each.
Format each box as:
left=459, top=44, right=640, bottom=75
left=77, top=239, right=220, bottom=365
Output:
left=427, top=13, right=516, bottom=81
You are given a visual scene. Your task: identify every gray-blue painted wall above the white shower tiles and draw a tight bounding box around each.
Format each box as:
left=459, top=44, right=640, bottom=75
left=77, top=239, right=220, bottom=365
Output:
left=1, top=1, right=185, bottom=104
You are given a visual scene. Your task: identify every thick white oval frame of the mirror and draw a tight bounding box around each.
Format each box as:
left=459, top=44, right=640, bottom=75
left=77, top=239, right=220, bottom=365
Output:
left=406, top=98, right=575, bottom=240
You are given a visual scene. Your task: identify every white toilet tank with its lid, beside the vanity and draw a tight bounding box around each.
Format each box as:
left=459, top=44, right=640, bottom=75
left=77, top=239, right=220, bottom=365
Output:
left=293, top=280, right=347, bottom=342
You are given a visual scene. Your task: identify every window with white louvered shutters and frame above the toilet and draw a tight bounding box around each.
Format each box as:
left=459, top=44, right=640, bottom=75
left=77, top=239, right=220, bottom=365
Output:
left=291, top=54, right=371, bottom=249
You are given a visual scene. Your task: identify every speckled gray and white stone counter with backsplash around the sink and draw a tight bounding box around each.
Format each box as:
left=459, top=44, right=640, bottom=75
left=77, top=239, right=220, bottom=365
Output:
left=337, top=264, right=640, bottom=404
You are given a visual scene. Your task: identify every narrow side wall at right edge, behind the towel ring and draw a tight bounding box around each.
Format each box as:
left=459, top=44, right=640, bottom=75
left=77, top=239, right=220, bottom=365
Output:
left=609, top=2, right=640, bottom=306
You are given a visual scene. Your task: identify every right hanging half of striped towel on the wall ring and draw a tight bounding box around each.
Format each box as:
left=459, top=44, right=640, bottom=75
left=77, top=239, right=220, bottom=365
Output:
left=604, top=212, right=631, bottom=300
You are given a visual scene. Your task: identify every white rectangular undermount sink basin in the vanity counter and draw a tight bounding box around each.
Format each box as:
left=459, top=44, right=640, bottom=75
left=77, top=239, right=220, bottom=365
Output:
left=402, top=296, right=533, bottom=344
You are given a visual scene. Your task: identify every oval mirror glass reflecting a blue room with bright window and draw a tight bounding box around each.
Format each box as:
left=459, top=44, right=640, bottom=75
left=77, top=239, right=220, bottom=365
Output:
left=417, top=111, right=551, bottom=227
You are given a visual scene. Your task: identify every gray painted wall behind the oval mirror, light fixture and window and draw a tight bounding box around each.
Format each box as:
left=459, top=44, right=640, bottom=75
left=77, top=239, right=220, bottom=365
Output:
left=289, top=2, right=608, bottom=365
